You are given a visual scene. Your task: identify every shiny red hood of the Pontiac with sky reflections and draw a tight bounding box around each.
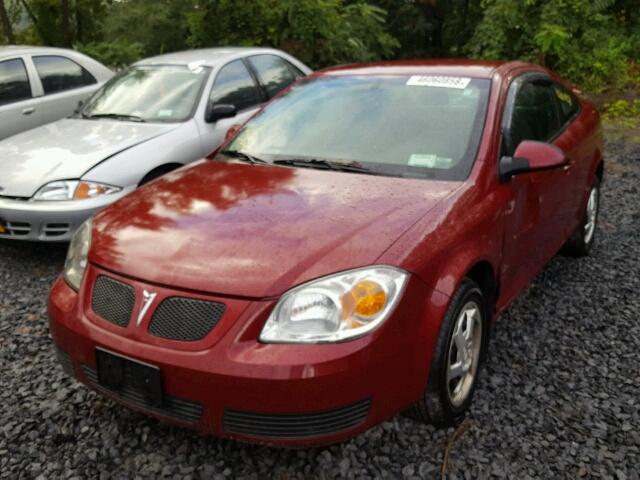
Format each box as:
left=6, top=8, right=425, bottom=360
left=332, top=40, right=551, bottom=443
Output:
left=89, top=160, right=459, bottom=298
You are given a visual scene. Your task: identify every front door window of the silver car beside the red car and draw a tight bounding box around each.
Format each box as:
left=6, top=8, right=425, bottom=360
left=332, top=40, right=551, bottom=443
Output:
left=210, top=60, right=262, bottom=110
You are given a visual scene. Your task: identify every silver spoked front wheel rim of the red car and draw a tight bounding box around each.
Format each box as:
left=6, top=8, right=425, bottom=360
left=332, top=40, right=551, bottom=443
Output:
left=447, top=301, right=483, bottom=407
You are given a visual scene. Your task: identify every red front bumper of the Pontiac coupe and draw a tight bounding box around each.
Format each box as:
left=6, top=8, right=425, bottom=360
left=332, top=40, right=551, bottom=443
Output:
left=49, top=266, right=448, bottom=446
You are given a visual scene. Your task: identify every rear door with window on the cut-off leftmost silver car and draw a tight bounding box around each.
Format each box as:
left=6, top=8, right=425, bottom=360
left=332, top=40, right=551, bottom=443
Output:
left=31, top=55, right=98, bottom=124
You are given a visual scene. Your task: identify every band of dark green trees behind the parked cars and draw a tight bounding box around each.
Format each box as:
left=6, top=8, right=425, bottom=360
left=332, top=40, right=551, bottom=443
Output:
left=0, top=0, right=640, bottom=92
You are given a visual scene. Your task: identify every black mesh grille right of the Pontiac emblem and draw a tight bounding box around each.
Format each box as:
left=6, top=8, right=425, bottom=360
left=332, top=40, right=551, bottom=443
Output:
left=149, top=297, right=225, bottom=342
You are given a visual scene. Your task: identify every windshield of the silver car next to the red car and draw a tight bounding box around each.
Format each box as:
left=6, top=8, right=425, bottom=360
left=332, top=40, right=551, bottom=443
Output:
left=80, top=65, right=210, bottom=122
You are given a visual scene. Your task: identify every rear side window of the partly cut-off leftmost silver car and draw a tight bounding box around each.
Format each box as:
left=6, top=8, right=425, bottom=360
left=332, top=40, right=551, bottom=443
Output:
left=33, top=56, right=97, bottom=95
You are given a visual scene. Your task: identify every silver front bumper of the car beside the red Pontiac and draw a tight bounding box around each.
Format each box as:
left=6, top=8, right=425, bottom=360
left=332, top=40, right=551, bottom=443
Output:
left=0, top=187, right=134, bottom=242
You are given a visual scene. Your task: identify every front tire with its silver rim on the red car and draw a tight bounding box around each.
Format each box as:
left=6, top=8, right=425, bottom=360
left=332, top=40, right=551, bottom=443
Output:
left=409, top=279, right=489, bottom=427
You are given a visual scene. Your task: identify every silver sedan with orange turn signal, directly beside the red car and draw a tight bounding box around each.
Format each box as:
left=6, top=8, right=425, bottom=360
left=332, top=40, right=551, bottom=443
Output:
left=0, top=48, right=311, bottom=241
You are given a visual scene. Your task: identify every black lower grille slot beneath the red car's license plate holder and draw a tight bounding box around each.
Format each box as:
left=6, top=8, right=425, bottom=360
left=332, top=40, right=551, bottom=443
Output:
left=80, top=365, right=202, bottom=423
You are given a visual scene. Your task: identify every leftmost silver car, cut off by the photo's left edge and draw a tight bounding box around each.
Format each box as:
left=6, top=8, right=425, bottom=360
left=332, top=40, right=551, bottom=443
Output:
left=0, top=47, right=113, bottom=140
